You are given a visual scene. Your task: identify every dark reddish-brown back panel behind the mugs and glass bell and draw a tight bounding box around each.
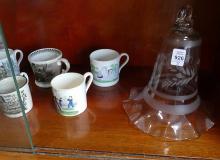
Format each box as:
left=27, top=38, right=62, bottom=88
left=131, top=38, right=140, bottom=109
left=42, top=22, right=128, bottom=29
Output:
left=0, top=0, right=220, bottom=78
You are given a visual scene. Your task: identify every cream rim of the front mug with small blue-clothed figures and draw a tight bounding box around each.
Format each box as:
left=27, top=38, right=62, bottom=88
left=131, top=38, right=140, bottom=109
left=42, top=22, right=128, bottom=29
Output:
left=50, top=72, right=85, bottom=91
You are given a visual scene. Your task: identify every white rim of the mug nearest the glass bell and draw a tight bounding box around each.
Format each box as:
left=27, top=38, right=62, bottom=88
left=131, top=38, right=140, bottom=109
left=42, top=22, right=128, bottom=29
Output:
left=89, top=48, right=120, bottom=63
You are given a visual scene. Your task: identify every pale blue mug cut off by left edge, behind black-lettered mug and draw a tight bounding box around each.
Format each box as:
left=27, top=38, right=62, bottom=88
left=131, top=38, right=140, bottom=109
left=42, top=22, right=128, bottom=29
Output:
left=0, top=49, right=23, bottom=80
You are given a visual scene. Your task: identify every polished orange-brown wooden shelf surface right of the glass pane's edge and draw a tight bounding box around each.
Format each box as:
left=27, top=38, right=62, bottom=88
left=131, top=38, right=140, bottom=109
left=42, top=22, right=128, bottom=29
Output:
left=0, top=68, right=220, bottom=159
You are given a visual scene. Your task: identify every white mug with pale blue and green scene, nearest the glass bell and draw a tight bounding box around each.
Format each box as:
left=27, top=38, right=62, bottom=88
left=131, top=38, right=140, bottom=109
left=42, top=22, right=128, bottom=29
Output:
left=90, top=49, right=129, bottom=87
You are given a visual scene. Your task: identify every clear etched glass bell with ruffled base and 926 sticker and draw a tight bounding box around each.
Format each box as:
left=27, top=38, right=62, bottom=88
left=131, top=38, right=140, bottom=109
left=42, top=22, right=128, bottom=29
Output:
left=124, top=6, right=214, bottom=140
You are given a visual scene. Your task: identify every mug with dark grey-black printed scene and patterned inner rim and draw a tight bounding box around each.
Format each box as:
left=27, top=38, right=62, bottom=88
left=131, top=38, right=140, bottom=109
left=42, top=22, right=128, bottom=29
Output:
left=28, top=48, right=70, bottom=88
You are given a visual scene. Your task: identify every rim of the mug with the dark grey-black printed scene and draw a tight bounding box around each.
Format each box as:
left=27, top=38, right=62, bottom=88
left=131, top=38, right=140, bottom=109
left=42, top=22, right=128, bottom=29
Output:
left=28, top=48, right=63, bottom=64
